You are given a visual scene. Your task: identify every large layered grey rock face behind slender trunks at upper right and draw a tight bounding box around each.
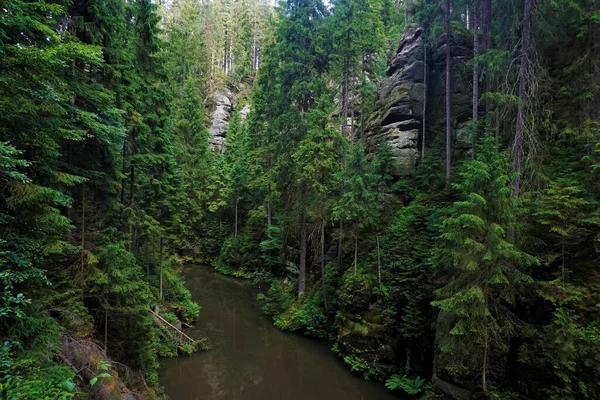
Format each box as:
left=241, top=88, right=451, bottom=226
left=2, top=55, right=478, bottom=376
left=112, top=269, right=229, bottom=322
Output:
left=367, top=25, right=472, bottom=176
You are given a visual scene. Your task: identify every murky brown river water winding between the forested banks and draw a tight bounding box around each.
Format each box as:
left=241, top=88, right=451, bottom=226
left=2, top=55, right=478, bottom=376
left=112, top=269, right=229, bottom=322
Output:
left=160, top=266, right=398, bottom=400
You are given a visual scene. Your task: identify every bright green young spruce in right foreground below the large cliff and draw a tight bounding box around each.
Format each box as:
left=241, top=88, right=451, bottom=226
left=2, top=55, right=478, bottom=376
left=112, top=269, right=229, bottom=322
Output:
left=432, top=136, right=537, bottom=393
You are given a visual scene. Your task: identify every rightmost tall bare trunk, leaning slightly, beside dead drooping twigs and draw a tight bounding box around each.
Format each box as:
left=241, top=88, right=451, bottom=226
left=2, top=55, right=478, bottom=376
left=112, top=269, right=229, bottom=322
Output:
left=512, top=0, right=532, bottom=198
